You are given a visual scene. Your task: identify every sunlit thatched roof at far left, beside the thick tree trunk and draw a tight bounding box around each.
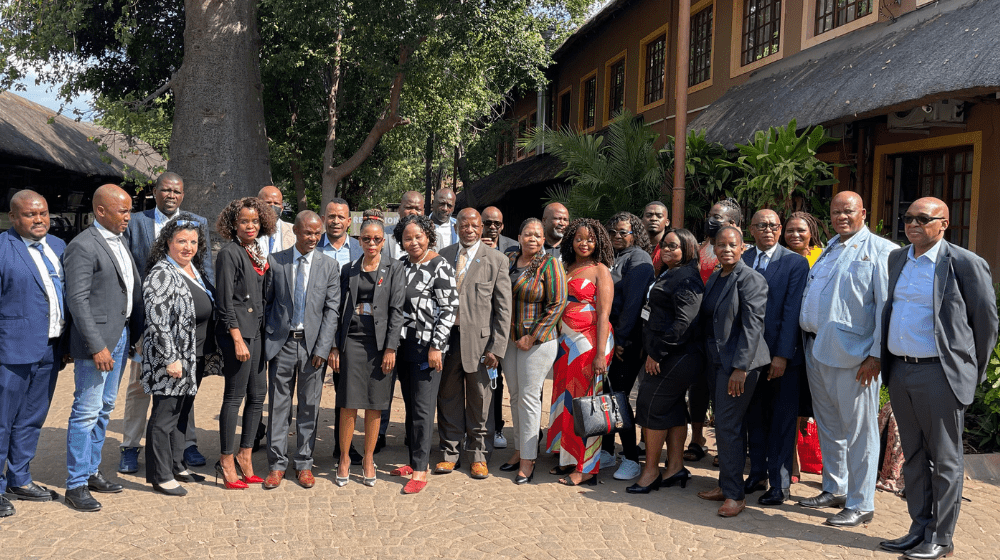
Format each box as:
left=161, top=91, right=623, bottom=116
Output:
left=0, top=91, right=167, bottom=181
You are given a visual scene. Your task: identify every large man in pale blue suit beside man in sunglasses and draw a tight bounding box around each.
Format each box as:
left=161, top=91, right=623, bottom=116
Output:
left=799, top=191, right=897, bottom=527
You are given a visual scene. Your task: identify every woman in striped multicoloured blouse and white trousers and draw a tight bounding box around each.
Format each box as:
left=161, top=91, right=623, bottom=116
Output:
left=500, top=218, right=566, bottom=484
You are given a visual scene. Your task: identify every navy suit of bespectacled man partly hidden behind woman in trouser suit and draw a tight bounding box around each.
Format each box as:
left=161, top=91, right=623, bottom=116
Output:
left=743, top=245, right=809, bottom=490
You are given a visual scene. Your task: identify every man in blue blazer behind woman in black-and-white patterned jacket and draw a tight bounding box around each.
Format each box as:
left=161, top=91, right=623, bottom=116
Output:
left=118, top=171, right=215, bottom=473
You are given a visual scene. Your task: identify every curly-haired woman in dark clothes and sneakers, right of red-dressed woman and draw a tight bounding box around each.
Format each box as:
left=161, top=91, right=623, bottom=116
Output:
left=601, top=212, right=655, bottom=480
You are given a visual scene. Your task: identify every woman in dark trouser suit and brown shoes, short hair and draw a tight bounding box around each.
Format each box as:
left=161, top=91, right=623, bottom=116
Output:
left=698, top=226, right=771, bottom=517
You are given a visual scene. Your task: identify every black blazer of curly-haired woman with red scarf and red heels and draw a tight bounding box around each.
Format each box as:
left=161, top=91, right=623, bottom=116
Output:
left=215, top=241, right=271, bottom=340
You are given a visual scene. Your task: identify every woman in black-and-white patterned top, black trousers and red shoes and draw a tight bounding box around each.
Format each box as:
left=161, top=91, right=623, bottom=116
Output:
left=391, top=212, right=458, bottom=494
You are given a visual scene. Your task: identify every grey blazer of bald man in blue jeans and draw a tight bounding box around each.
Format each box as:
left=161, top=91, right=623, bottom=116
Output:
left=63, top=226, right=143, bottom=360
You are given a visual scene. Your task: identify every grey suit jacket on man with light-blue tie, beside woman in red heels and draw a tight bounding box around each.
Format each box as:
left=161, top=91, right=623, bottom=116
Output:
left=264, top=248, right=340, bottom=360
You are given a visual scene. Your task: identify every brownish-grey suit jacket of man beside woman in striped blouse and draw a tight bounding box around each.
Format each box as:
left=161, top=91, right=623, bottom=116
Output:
left=441, top=243, right=511, bottom=373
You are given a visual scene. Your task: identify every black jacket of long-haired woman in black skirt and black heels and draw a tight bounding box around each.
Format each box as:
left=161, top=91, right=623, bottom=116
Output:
left=642, top=260, right=705, bottom=362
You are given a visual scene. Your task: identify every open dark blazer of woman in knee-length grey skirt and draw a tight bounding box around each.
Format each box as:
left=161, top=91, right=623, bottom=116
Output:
left=337, top=254, right=406, bottom=352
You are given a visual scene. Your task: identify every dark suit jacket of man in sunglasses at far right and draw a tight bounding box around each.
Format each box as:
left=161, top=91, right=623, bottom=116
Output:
left=882, top=240, right=997, bottom=405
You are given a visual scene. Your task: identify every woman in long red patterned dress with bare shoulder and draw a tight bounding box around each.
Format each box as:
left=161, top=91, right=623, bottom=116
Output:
left=548, top=218, right=615, bottom=486
